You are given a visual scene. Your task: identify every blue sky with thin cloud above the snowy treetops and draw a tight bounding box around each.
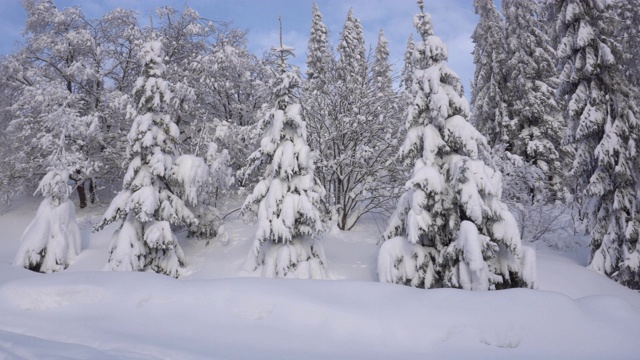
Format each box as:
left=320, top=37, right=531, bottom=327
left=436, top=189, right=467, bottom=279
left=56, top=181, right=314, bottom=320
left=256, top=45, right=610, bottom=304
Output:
left=0, top=0, right=478, bottom=96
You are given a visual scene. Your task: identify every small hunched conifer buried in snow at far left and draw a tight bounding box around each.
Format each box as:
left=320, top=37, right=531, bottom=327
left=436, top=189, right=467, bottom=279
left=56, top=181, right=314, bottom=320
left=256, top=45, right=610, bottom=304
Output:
left=13, top=169, right=80, bottom=273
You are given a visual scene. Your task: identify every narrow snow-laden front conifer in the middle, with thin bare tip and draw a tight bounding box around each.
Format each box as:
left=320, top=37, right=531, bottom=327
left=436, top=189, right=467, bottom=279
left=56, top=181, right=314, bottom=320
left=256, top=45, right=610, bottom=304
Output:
left=242, top=23, right=326, bottom=279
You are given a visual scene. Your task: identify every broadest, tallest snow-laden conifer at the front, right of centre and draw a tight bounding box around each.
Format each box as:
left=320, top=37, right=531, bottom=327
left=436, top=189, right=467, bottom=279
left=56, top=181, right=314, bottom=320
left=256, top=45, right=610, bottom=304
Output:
left=378, top=0, right=535, bottom=290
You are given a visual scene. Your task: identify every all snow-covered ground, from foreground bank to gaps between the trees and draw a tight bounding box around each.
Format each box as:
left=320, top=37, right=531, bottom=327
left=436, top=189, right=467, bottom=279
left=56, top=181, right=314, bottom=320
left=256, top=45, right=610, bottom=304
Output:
left=0, top=198, right=640, bottom=359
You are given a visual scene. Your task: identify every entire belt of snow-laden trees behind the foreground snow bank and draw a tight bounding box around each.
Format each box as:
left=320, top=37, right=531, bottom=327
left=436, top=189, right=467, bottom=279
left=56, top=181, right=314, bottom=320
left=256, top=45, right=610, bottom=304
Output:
left=5, top=0, right=640, bottom=289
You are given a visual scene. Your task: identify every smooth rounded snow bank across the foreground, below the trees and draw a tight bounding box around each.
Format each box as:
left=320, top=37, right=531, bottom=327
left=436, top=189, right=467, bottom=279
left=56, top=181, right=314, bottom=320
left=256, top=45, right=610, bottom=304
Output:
left=0, top=272, right=640, bottom=359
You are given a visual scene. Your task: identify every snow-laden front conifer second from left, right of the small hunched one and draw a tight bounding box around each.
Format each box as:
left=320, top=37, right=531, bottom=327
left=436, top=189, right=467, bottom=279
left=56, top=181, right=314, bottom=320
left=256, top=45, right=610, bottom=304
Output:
left=94, top=40, right=200, bottom=277
